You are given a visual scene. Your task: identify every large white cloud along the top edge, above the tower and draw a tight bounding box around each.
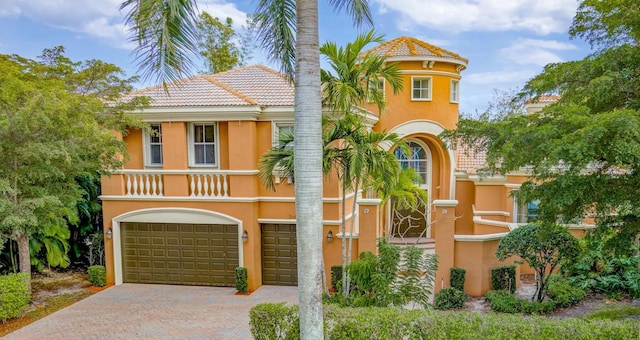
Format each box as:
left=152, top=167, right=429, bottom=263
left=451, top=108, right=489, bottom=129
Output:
left=373, top=0, right=577, bottom=35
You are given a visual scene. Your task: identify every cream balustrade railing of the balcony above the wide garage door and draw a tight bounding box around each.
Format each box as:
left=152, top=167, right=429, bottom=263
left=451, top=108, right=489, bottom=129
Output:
left=114, top=170, right=257, bottom=198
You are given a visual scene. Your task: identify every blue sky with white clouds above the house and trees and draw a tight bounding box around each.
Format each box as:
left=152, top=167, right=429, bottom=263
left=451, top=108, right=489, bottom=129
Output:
left=0, top=0, right=593, bottom=116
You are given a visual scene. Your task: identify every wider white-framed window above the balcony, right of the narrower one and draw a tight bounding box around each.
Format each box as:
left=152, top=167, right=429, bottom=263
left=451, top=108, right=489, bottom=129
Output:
left=189, top=123, right=218, bottom=166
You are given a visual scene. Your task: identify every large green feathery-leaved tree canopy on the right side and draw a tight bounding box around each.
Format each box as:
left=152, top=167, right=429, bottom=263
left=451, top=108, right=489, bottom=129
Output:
left=443, top=0, right=640, bottom=249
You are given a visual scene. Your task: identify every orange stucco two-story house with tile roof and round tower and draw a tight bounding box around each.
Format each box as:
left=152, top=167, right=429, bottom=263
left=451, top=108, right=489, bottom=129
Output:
left=101, top=37, right=583, bottom=295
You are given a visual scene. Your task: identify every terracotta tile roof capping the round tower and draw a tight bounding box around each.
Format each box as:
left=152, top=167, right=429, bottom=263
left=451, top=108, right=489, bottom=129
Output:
left=364, top=37, right=469, bottom=64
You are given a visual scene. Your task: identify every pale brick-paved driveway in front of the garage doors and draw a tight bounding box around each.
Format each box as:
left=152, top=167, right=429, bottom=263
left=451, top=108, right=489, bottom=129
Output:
left=6, top=284, right=298, bottom=339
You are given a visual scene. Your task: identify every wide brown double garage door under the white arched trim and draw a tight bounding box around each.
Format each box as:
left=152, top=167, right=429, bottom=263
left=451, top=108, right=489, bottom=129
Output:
left=121, top=223, right=238, bottom=286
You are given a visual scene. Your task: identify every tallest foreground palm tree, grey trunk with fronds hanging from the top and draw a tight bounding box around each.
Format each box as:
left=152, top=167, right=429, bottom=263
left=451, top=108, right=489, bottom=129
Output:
left=121, top=0, right=371, bottom=339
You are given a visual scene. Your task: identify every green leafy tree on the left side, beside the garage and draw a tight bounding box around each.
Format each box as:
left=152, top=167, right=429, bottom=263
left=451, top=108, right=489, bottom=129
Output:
left=0, top=47, right=145, bottom=280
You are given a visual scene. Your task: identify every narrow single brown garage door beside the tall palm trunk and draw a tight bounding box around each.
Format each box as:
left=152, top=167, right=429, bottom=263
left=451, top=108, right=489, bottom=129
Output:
left=261, top=224, right=298, bottom=286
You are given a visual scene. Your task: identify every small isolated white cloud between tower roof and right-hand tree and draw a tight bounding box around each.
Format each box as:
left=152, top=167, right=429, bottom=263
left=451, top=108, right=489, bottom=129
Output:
left=500, top=39, right=577, bottom=66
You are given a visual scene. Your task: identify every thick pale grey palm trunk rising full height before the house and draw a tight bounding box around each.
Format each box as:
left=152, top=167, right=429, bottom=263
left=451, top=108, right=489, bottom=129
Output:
left=294, top=0, right=323, bottom=340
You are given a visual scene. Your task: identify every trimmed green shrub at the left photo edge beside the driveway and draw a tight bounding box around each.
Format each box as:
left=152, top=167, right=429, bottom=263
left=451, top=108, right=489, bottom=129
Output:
left=0, top=273, right=31, bottom=323
